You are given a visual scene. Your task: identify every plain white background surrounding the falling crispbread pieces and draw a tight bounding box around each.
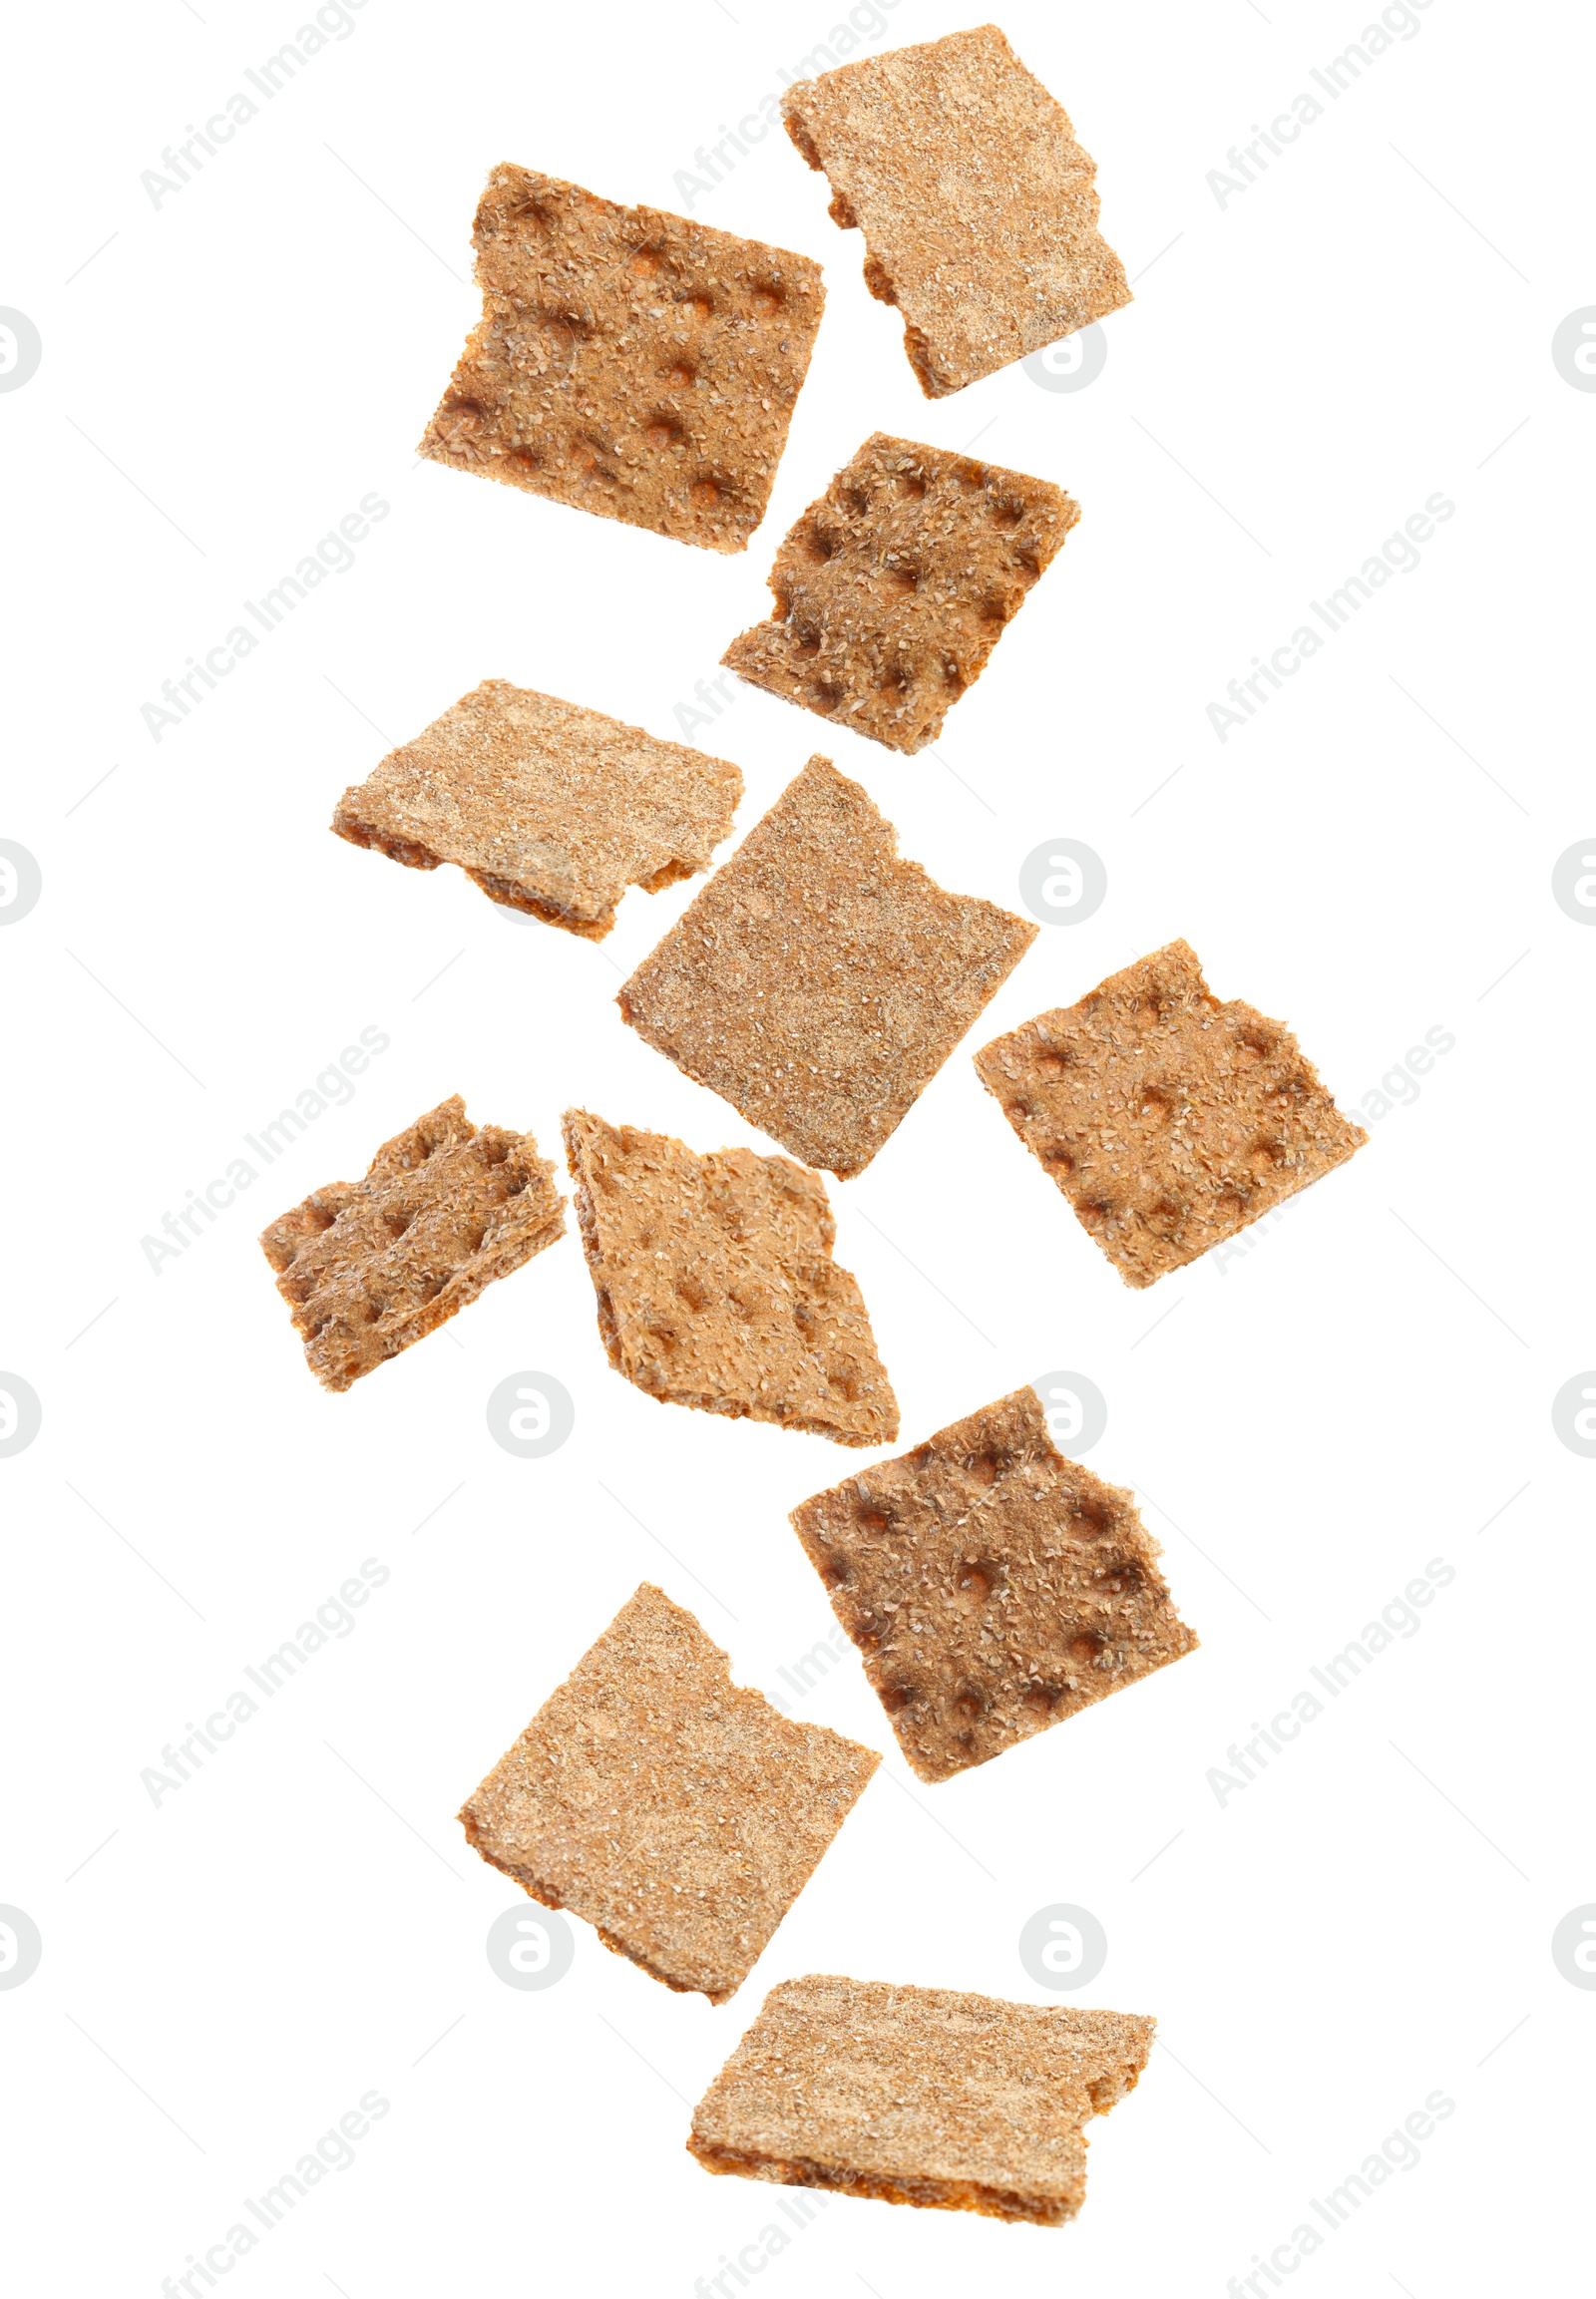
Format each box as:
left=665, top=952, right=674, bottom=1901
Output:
left=0, top=0, right=1596, bottom=2299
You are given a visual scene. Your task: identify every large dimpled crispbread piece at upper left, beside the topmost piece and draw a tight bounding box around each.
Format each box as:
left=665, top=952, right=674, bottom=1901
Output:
left=419, top=166, right=826, bottom=552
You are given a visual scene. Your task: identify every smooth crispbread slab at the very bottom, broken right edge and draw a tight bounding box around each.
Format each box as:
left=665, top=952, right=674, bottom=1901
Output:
left=687, top=1973, right=1157, bottom=2228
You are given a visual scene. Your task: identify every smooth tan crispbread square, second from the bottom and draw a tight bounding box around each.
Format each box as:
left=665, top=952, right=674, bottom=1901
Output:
left=460, top=1582, right=881, bottom=2003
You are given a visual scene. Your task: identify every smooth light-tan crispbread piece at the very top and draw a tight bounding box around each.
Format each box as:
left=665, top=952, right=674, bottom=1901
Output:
left=782, top=23, right=1131, bottom=400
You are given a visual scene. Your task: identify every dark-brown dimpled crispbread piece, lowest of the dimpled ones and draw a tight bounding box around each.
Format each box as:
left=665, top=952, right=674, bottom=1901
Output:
left=791, top=1388, right=1198, bottom=1779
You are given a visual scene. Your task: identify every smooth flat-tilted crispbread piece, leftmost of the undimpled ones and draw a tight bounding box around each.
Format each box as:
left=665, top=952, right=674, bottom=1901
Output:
left=333, top=678, right=743, bottom=943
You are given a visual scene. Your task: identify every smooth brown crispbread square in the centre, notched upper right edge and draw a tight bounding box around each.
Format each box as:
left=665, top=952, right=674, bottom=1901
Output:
left=616, top=759, right=1037, bottom=1175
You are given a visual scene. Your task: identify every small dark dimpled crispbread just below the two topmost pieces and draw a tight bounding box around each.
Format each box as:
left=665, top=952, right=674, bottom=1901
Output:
left=720, top=432, right=1081, bottom=754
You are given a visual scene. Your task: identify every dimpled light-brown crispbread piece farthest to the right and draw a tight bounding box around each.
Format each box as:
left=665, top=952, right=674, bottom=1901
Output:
left=976, top=943, right=1369, bottom=1285
